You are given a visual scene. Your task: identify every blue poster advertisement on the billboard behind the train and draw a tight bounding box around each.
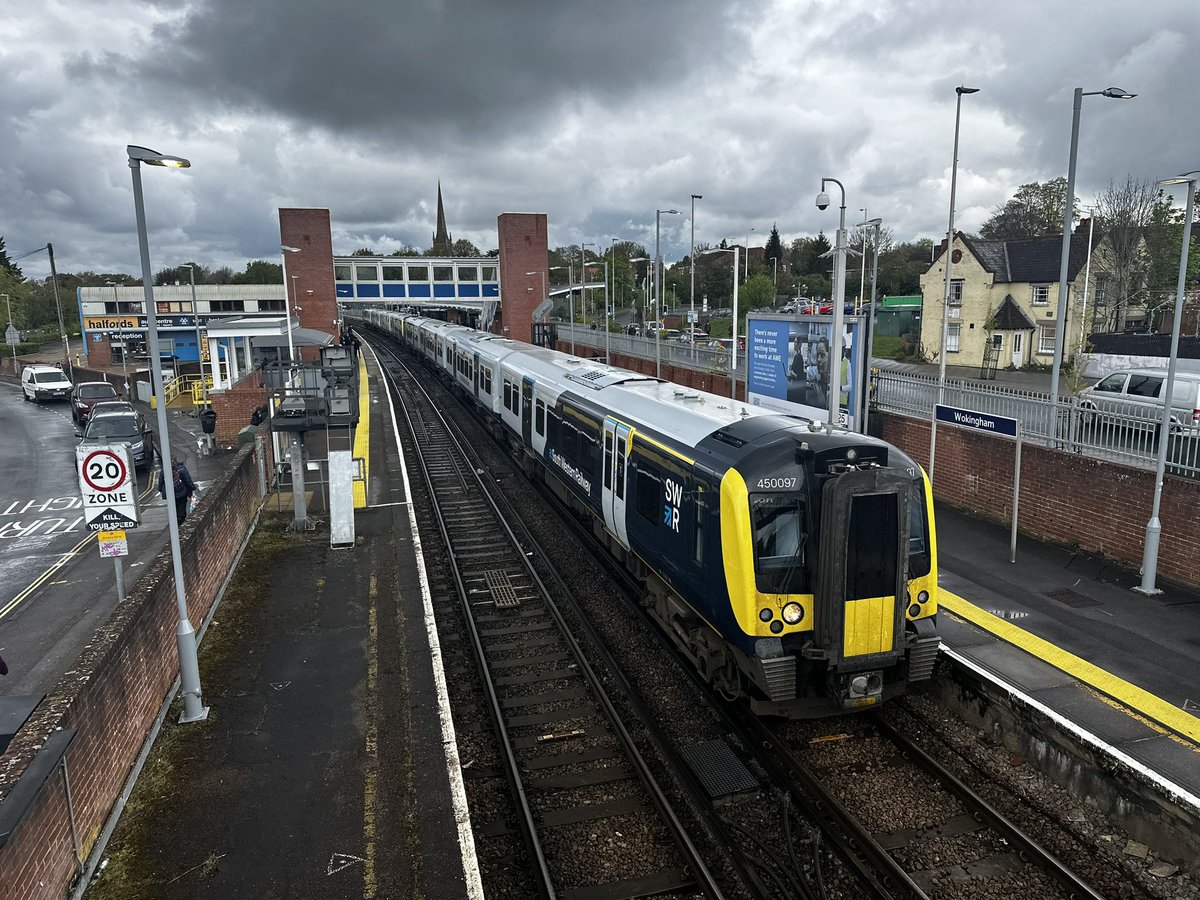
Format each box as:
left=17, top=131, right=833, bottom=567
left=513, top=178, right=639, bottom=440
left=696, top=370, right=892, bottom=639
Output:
left=746, top=316, right=864, bottom=431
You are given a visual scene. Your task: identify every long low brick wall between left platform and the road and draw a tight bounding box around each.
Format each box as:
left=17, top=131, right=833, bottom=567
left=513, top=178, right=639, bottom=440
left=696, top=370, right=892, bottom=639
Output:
left=0, top=446, right=271, bottom=900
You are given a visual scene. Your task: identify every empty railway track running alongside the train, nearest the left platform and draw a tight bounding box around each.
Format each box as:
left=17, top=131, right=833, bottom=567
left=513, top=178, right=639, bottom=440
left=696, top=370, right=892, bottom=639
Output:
left=385, top=345, right=722, bottom=900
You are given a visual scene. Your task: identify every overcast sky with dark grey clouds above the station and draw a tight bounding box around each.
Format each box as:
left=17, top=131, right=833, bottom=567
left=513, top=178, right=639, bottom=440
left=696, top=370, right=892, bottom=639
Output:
left=0, top=0, right=1200, bottom=277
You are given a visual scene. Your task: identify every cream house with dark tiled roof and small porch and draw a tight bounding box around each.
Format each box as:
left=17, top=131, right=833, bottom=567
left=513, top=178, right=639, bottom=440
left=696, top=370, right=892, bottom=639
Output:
left=920, top=227, right=1099, bottom=368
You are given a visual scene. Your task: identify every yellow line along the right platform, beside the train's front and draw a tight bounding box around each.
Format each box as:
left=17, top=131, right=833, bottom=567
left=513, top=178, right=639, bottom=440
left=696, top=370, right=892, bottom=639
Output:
left=938, top=588, right=1200, bottom=743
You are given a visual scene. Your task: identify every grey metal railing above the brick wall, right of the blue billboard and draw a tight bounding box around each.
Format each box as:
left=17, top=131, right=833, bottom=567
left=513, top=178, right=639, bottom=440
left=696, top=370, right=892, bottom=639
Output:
left=872, top=370, right=1200, bottom=478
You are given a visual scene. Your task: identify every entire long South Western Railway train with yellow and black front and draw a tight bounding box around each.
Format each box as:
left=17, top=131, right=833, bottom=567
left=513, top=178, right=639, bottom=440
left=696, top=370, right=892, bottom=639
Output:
left=350, top=308, right=940, bottom=718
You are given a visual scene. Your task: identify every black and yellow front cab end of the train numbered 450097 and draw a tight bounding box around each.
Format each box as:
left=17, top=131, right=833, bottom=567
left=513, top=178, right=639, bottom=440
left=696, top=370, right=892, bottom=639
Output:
left=721, top=442, right=938, bottom=718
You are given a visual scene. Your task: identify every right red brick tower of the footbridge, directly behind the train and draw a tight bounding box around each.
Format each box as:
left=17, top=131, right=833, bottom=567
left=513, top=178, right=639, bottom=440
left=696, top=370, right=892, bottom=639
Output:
left=492, top=212, right=550, bottom=343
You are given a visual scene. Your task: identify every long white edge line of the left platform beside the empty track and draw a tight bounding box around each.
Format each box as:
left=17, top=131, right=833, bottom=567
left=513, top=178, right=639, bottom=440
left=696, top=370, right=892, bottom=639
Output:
left=362, top=341, right=484, bottom=900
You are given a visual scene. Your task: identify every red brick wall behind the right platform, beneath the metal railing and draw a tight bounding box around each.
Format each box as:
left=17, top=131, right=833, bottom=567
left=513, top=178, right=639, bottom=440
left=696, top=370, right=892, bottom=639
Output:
left=872, top=413, right=1200, bottom=588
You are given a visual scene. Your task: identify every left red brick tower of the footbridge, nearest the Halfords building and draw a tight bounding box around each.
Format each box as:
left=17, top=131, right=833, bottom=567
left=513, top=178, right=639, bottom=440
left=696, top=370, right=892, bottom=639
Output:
left=279, top=209, right=338, bottom=360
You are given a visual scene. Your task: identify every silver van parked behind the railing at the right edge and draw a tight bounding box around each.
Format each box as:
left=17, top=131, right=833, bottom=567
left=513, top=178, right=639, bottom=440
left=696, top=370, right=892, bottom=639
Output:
left=1079, top=368, right=1200, bottom=436
